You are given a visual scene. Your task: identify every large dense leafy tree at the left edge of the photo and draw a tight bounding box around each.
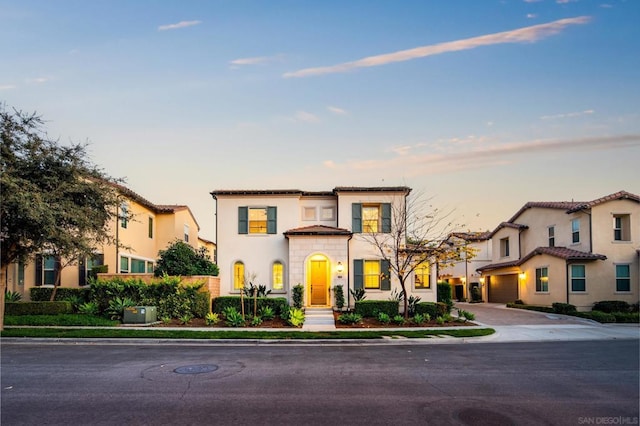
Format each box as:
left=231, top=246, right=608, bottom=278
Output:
left=0, top=104, right=119, bottom=328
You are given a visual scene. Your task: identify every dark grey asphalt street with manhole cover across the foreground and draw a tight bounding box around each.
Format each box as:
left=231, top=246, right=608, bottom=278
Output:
left=1, top=340, right=639, bottom=425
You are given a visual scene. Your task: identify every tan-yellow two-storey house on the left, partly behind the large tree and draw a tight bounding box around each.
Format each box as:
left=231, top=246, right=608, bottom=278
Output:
left=8, top=185, right=215, bottom=299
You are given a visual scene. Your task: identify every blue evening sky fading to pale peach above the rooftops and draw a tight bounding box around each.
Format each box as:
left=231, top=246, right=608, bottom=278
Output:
left=0, top=0, right=640, bottom=240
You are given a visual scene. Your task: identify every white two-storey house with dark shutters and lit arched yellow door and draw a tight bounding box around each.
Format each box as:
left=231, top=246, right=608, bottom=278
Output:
left=211, top=187, right=436, bottom=307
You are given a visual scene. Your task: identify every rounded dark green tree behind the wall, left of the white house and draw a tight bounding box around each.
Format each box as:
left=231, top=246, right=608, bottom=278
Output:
left=154, top=240, right=218, bottom=277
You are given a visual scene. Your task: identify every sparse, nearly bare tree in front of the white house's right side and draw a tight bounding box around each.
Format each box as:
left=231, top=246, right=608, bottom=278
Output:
left=361, top=190, right=473, bottom=319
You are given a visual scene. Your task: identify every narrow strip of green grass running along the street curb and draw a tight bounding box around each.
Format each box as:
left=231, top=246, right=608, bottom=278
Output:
left=0, top=327, right=495, bottom=340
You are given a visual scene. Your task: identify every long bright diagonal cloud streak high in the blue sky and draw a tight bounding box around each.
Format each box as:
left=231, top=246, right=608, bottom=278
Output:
left=283, top=16, right=591, bottom=78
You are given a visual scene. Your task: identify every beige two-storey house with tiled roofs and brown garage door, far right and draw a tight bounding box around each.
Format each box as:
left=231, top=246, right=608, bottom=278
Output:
left=478, top=191, right=640, bottom=310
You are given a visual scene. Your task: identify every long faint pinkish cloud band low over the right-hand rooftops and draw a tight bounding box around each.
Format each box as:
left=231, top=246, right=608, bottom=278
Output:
left=323, top=134, right=640, bottom=176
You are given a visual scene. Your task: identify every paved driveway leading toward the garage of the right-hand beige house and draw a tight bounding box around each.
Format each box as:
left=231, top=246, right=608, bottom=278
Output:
left=453, top=302, right=593, bottom=326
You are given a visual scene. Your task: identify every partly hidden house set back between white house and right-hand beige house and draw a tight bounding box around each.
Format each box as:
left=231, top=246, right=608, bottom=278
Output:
left=438, top=231, right=493, bottom=300
